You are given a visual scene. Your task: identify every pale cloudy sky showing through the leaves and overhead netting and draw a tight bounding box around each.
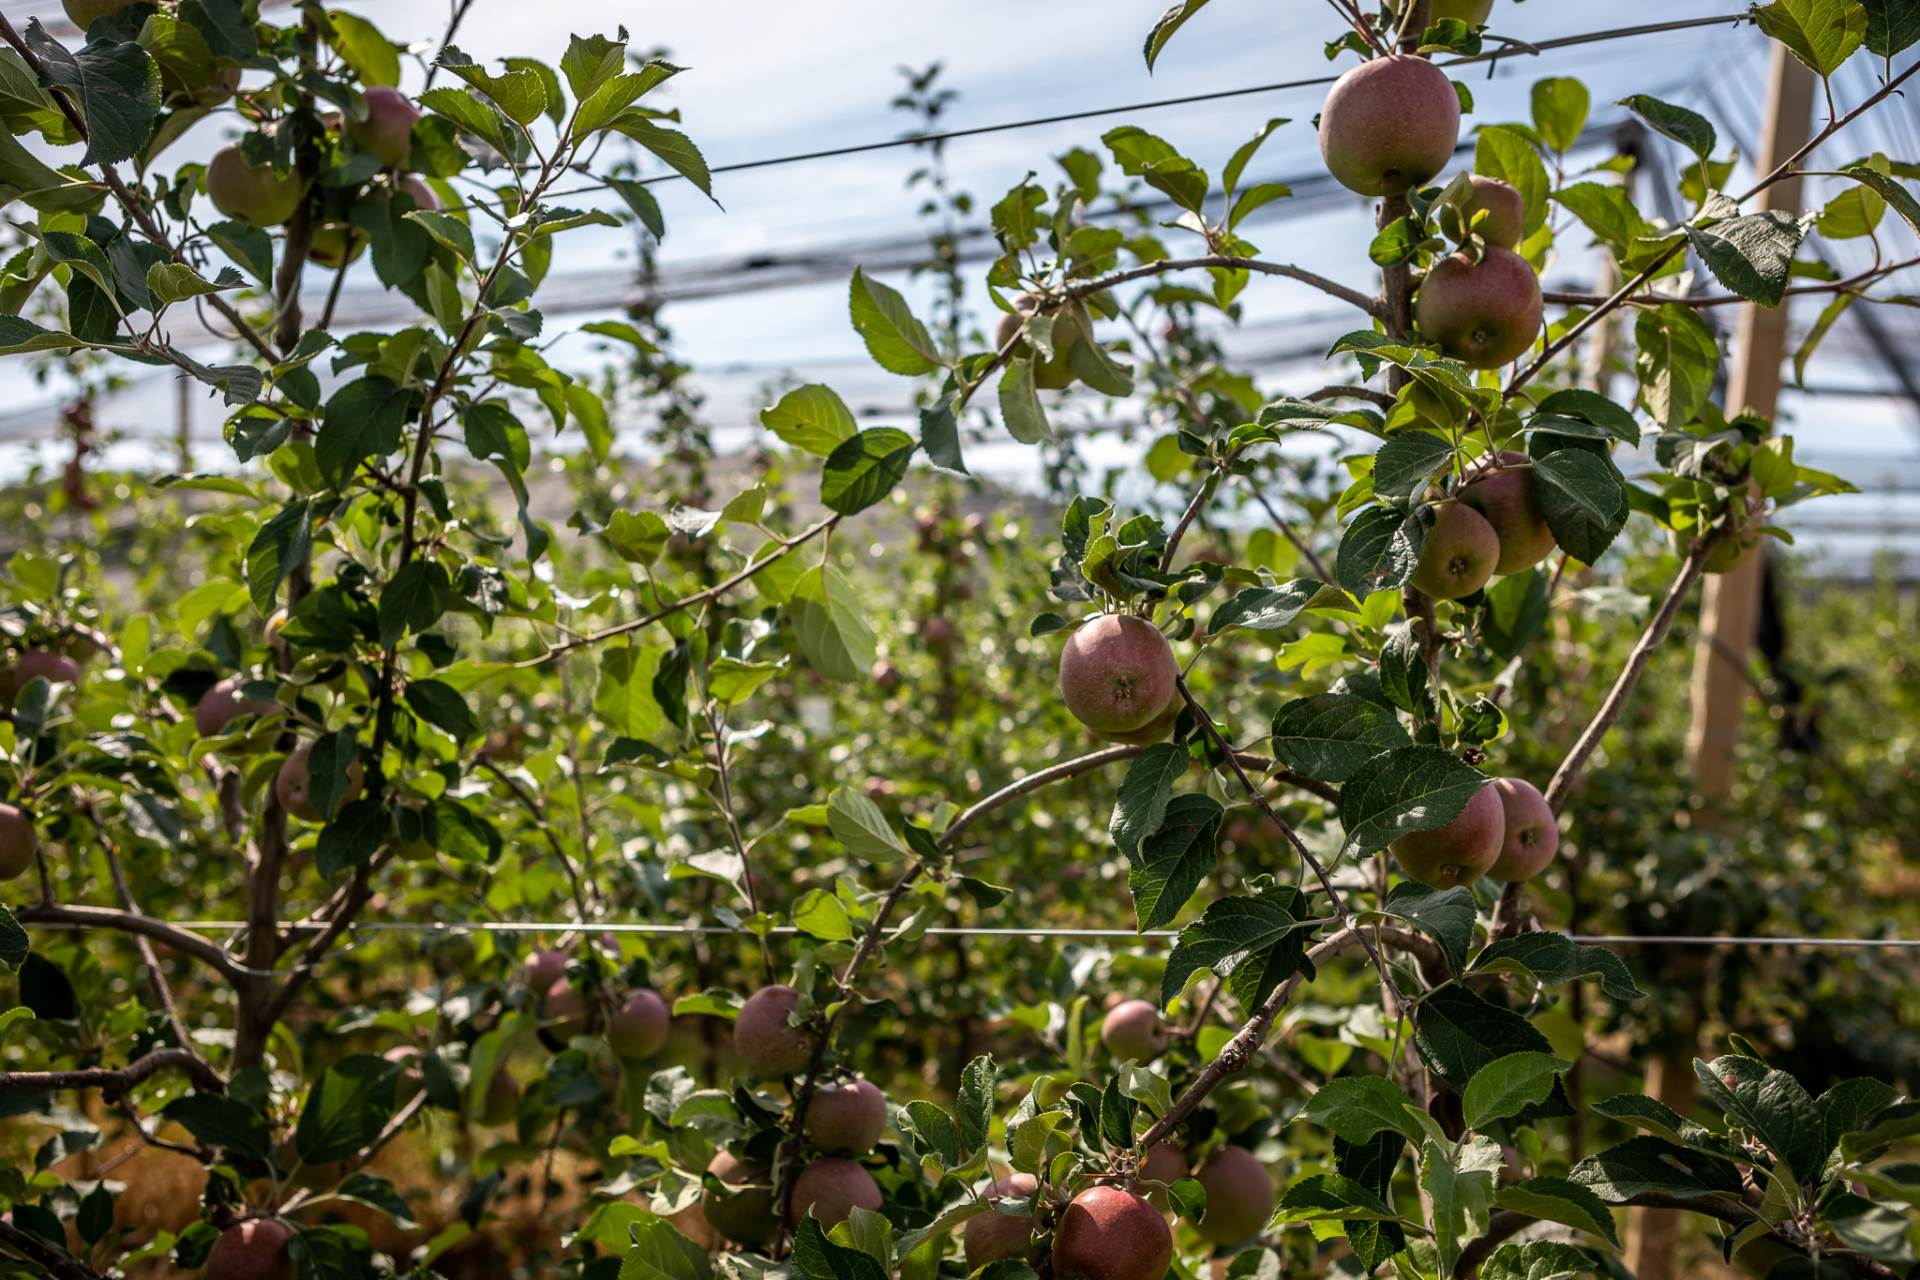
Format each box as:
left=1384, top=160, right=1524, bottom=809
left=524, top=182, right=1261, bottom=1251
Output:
left=0, top=0, right=1920, bottom=575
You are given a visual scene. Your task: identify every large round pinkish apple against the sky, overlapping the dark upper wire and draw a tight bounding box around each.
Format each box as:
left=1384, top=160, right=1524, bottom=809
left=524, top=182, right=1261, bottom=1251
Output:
left=1321, top=56, right=1459, bottom=196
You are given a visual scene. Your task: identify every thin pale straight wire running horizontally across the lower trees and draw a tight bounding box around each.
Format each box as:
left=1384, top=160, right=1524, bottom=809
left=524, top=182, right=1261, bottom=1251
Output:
left=18, top=919, right=1920, bottom=950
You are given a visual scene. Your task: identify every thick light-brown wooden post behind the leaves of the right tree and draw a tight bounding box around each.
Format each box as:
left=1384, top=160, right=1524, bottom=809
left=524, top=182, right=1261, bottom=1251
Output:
left=1626, top=44, right=1814, bottom=1280
